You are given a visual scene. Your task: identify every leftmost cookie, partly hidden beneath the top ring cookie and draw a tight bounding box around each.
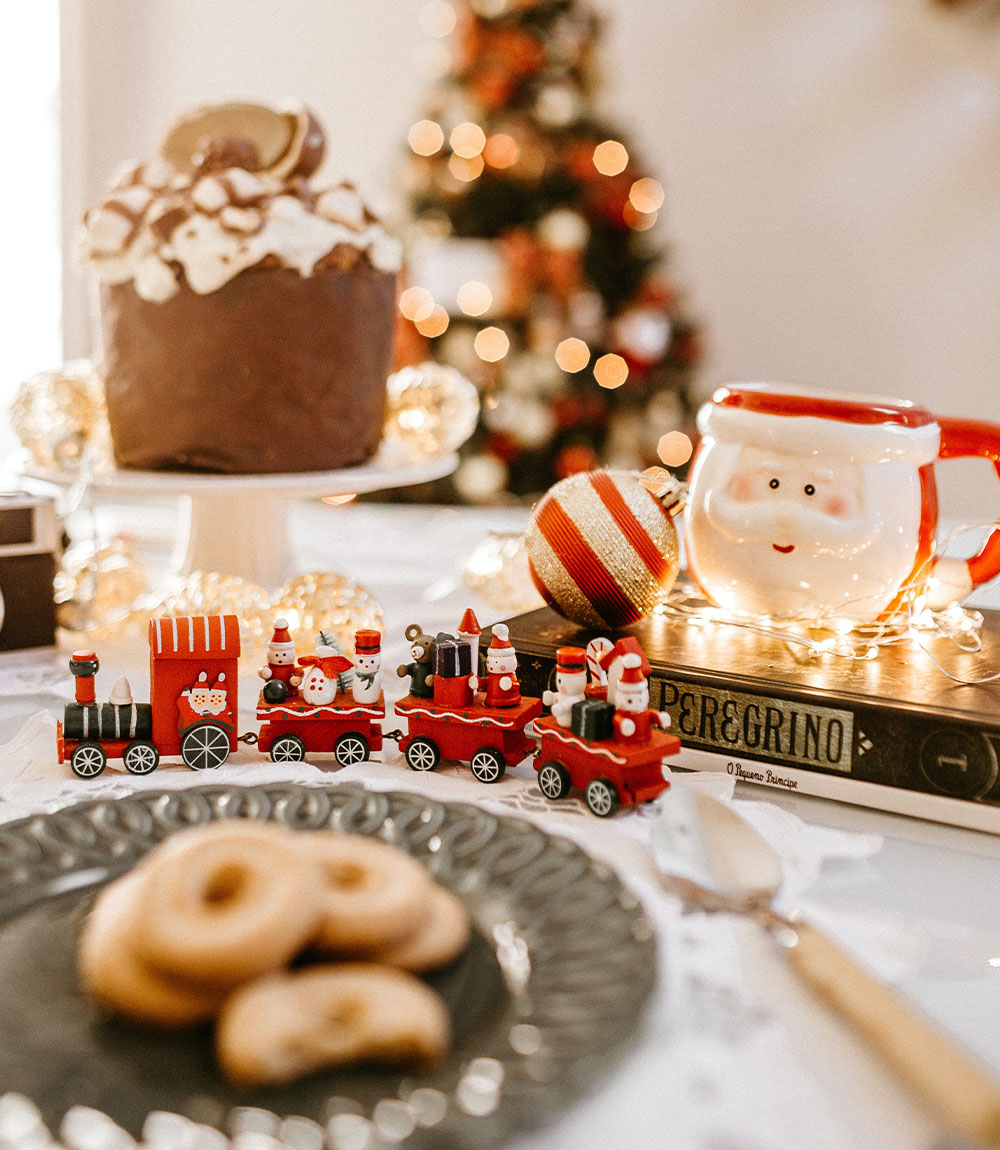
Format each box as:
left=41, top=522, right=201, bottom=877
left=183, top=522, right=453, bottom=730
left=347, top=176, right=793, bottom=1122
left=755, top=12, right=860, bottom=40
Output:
left=77, top=872, right=222, bottom=1029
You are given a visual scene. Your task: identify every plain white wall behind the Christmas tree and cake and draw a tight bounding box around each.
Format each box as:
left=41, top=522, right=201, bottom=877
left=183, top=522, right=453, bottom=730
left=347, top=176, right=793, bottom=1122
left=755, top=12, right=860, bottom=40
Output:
left=63, top=0, right=1000, bottom=516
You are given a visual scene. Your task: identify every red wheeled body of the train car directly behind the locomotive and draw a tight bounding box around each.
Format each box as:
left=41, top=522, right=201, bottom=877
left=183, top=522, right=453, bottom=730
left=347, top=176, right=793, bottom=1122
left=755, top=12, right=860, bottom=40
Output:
left=257, top=691, right=385, bottom=767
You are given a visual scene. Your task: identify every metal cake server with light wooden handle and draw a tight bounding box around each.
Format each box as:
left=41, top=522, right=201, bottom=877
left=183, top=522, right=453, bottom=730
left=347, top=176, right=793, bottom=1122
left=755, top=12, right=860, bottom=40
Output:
left=652, top=788, right=1000, bottom=1147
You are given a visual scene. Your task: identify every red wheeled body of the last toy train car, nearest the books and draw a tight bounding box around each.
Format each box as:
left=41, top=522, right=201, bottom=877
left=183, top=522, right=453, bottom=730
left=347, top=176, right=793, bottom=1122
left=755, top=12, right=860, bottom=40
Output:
left=534, top=715, right=680, bottom=818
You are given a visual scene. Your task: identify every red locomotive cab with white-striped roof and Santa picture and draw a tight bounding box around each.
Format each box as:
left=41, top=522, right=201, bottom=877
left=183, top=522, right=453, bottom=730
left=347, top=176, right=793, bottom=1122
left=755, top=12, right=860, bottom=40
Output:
left=149, top=615, right=240, bottom=766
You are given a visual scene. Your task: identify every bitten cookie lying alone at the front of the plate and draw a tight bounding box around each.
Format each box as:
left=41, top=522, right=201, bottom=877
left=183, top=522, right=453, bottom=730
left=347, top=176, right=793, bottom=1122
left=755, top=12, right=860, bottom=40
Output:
left=216, top=963, right=451, bottom=1086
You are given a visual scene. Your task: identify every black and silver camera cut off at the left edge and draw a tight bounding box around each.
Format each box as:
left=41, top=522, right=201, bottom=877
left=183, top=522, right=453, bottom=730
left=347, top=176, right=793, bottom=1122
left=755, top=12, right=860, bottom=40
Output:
left=0, top=491, right=60, bottom=651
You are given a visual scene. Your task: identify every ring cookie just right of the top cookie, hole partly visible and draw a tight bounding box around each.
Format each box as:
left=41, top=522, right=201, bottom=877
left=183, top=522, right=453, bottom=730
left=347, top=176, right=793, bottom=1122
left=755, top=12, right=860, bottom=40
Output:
left=298, top=831, right=437, bottom=956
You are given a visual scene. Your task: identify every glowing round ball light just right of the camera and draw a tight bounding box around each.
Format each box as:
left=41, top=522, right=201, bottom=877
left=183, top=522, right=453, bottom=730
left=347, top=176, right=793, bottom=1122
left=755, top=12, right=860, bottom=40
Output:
left=55, top=535, right=149, bottom=631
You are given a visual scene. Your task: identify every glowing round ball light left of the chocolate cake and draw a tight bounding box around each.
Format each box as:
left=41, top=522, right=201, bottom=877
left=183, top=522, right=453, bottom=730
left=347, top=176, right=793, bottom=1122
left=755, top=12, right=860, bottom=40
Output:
left=10, top=360, right=114, bottom=472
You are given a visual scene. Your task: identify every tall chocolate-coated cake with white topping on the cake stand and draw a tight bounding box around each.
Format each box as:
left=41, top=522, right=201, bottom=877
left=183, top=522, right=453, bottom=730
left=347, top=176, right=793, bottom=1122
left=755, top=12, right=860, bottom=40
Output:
left=84, top=105, right=400, bottom=474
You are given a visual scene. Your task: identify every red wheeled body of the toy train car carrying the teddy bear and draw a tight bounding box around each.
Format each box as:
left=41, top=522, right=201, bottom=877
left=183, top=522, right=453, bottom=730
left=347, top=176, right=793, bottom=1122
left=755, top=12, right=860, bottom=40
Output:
left=395, top=695, right=541, bottom=783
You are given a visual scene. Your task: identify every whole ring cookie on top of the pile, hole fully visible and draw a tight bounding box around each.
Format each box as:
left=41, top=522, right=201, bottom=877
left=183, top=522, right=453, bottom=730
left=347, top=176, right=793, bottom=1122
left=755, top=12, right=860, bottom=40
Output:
left=134, top=819, right=322, bottom=986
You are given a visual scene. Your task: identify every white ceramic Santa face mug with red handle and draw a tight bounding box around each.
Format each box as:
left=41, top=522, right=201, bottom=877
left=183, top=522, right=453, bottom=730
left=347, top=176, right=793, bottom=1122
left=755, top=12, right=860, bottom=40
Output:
left=686, top=384, right=1000, bottom=622
